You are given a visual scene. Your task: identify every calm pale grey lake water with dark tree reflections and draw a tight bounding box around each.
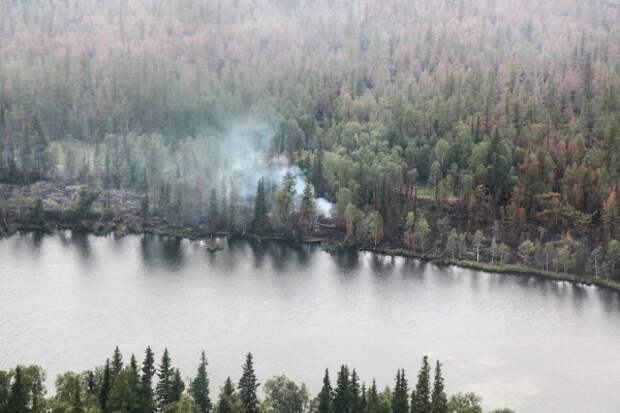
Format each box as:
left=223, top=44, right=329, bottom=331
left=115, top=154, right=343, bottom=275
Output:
left=0, top=233, right=620, bottom=413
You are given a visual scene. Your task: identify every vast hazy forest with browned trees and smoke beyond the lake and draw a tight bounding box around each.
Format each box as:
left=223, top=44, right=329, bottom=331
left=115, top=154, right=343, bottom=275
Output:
left=0, top=0, right=620, bottom=279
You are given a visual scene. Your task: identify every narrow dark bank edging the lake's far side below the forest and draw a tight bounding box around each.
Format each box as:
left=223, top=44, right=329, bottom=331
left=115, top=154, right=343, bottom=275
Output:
left=0, top=222, right=620, bottom=293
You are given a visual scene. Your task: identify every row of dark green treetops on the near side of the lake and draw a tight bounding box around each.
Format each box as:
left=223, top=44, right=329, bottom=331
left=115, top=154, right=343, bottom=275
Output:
left=0, top=347, right=512, bottom=413
